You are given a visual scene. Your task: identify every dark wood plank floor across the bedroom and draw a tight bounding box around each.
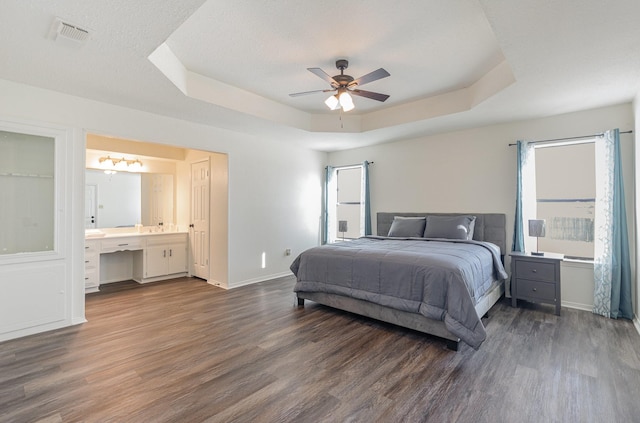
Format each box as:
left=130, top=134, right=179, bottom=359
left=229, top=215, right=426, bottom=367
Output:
left=0, top=278, right=640, bottom=423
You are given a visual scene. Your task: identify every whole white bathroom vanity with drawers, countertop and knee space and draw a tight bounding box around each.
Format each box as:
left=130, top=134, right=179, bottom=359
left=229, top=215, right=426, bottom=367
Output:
left=85, top=229, right=188, bottom=293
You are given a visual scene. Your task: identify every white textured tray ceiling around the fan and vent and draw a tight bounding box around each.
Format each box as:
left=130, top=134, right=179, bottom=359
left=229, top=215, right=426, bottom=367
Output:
left=0, top=0, right=640, bottom=151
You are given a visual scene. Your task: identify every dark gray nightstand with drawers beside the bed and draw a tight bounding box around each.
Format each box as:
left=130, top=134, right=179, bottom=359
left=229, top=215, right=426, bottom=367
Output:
left=510, top=252, right=564, bottom=316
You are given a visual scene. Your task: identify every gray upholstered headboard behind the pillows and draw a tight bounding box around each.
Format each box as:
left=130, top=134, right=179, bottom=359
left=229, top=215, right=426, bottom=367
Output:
left=377, top=212, right=507, bottom=255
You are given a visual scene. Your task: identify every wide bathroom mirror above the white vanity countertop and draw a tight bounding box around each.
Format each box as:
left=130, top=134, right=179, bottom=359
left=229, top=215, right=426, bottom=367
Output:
left=85, top=169, right=175, bottom=229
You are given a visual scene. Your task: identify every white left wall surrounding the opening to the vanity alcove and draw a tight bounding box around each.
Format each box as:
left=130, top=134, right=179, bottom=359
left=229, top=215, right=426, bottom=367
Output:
left=0, top=80, right=326, bottom=342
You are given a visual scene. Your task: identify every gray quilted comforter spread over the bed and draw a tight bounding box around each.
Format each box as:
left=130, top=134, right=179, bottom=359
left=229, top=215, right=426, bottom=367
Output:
left=291, top=237, right=507, bottom=349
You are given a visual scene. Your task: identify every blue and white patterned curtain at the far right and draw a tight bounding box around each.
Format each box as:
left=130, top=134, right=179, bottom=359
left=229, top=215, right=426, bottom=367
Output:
left=593, top=129, right=633, bottom=319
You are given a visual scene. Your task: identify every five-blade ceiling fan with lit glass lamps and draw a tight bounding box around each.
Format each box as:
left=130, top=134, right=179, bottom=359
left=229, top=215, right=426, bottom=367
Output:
left=289, top=59, right=389, bottom=112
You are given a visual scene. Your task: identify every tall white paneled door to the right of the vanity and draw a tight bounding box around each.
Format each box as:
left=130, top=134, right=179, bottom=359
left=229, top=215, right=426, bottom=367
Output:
left=189, top=159, right=210, bottom=280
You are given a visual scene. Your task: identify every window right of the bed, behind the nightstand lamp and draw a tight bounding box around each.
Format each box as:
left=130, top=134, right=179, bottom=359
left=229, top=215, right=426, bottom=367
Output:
left=535, top=140, right=596, bottom=260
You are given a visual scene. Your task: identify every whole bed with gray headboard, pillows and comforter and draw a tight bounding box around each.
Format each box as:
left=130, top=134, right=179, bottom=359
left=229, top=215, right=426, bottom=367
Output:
left=291, top=212, right=507, bottom=350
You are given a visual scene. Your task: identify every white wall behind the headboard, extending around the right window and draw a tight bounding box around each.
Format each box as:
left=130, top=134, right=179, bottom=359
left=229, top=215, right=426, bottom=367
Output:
left=329, top=104, right=636, bottom=308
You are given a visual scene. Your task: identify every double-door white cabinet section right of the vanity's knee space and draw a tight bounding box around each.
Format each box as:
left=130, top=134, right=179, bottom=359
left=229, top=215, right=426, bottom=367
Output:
left=140, top=234, right=187, bottom=283
